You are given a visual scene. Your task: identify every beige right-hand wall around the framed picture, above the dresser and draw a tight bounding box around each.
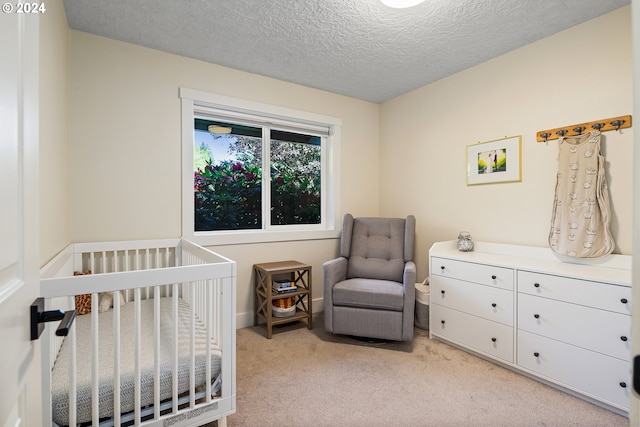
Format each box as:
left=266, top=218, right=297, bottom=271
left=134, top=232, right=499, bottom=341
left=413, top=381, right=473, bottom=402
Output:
left=380, top=7, right=633, bottom=279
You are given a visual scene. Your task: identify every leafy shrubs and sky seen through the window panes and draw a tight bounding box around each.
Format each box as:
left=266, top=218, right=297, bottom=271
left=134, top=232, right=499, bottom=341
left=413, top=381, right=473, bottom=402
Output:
left=193, top=118, right=322, bottom=231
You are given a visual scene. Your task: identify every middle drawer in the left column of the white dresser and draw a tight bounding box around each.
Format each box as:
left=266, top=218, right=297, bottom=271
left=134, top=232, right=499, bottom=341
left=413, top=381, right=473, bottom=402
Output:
left=429, top=276, right=513, bottom=326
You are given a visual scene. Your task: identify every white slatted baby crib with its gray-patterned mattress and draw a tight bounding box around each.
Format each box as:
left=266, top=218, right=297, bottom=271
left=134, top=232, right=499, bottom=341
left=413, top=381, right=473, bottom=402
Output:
left=41, top=239, right=236, bottom=426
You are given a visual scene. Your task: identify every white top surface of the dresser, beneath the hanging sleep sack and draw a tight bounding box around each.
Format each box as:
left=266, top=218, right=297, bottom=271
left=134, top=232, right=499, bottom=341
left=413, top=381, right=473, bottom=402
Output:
left=429, top=240, right=632, bottom=286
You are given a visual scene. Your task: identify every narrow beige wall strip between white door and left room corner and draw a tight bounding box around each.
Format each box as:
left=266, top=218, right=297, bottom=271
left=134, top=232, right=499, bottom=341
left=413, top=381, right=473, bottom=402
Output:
left=39, top=2, right=70, bottom=264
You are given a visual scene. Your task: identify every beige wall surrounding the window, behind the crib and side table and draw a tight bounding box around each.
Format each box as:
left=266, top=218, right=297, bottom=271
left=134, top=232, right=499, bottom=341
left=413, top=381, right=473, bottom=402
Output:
left=70, top=31, right=379, bottom=320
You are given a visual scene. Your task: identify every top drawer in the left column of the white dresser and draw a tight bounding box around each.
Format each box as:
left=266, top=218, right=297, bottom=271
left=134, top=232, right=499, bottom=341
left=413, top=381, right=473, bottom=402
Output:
left=431, top=257, right=514, bottom=290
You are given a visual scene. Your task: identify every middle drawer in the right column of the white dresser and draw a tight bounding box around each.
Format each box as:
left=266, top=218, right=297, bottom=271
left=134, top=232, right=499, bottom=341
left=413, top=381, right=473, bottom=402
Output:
left=518, top=294, right=631, bottom=361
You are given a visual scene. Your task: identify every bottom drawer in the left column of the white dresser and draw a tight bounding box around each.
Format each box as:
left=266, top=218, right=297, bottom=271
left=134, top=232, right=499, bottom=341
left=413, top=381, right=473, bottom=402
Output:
left=429, top=304, right=513, bottom=363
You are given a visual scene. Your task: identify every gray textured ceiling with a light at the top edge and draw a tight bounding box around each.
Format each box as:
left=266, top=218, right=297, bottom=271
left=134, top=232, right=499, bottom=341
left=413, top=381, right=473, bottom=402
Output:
left=64, top=0, right=630, bottom=102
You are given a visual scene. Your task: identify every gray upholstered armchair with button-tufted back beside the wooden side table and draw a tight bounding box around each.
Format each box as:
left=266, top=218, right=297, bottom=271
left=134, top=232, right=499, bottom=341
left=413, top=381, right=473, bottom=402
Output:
left=322, top=214, right=416, bottom=341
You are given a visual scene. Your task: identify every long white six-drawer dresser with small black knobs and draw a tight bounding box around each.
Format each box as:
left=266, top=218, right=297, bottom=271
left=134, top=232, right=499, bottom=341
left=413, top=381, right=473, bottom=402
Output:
left=429, top=241, right=631, bottom=415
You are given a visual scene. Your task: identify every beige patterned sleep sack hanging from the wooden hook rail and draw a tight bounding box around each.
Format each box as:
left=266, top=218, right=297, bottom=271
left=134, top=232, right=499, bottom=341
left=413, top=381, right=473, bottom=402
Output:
left=549, top=131, right=615, bottom=258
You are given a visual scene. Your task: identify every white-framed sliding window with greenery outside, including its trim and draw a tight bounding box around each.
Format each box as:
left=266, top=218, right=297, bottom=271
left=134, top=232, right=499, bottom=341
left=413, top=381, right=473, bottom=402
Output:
left=180, top=89, right=341, bottom=245
